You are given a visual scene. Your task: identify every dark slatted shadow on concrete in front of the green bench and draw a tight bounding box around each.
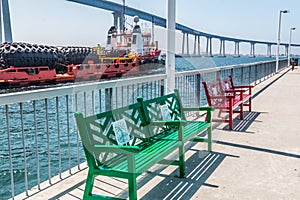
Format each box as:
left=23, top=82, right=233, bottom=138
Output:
left=138, top=149, right=237, bottom=200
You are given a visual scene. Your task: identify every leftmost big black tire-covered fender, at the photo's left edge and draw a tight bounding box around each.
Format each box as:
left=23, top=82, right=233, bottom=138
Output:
left=0, top=42, right=63, bottom=69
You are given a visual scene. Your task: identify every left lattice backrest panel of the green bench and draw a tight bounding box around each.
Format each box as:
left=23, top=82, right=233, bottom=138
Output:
left=75, top=103, right=149, bottom=167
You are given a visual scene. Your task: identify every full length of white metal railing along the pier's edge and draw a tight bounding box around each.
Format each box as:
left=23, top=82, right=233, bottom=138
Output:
left=0, top=60, right=286, bottom=199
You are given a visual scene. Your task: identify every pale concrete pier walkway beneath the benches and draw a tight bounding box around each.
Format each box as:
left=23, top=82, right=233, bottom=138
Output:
left=16, top=68, right=300, bottom=200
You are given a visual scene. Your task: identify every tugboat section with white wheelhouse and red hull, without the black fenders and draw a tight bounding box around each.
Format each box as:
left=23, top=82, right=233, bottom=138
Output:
left=68, top=16, right=161, bottom=81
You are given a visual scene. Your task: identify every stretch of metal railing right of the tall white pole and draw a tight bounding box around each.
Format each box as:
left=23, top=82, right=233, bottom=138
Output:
left=176, top=60, right=287, bottom=106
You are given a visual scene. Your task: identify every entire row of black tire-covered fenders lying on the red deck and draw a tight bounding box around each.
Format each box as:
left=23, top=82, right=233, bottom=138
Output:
left=0, top=42, right=99, bottom=73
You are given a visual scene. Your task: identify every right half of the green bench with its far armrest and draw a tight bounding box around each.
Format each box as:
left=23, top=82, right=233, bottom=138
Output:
left=137, top=89, right=214, bottom=177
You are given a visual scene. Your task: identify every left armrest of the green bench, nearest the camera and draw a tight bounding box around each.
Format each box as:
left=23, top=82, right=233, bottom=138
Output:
left=94, top=145, right=141, bottom=154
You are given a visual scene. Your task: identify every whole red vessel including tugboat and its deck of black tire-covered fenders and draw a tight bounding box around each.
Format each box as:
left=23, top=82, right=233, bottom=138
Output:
left=0, top=17, right=162, bottom=88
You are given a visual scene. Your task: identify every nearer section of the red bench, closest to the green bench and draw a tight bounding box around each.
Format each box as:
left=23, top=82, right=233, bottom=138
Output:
left=202, top=80, right=243, bottom=130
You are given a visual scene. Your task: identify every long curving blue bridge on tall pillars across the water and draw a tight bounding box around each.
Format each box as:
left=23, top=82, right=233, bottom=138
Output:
left=0, top=0, right=300, bottom=57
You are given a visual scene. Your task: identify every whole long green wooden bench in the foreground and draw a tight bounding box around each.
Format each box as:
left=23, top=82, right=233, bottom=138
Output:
left=75, top=89, right=212, bottom=199
